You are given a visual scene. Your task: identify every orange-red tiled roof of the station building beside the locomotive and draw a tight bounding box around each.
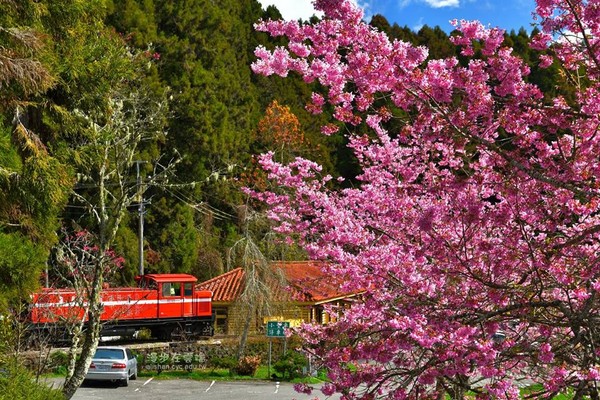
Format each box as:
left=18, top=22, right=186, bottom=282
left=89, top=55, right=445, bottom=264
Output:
left=197, top=261, right=355, bottom=303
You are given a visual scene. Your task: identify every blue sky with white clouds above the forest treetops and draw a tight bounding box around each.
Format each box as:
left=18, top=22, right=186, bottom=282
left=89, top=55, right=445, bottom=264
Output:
left=259, top=0, right=535, bottom=32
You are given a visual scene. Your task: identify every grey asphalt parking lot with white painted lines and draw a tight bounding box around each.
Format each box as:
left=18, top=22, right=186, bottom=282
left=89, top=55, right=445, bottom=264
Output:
left=51, top=378, right=340, bottom=400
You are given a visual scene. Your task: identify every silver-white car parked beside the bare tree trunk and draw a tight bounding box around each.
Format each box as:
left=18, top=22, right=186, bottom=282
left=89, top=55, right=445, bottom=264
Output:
left=85, top=346, right=137, bottom=386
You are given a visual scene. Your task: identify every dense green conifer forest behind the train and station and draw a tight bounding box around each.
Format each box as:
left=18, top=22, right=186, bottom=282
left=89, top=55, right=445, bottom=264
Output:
left=0, top=0, right=561, bottom=306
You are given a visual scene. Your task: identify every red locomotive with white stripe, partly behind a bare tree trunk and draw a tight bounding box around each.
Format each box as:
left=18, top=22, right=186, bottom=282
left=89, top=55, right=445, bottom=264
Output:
left=30, top=274, right=214, bottom=340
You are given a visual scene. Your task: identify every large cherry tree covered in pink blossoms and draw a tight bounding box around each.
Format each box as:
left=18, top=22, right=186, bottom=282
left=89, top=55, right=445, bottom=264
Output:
left=253, top=0, right=600, bottom=399
